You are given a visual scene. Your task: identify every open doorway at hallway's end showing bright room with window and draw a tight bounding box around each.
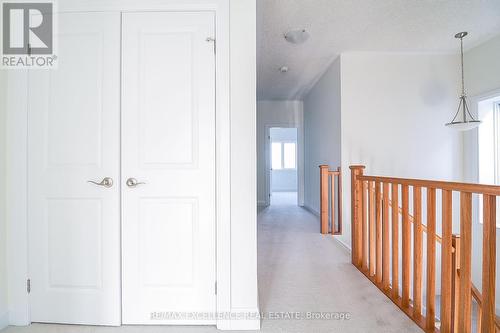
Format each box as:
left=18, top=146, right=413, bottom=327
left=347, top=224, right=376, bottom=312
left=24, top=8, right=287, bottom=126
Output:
left=269, top=127, right=298, bottom=205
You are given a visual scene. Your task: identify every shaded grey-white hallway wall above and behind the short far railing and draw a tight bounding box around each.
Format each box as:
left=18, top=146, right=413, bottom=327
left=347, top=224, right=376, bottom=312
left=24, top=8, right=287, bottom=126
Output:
left=304, top=58, right=342, bottom=217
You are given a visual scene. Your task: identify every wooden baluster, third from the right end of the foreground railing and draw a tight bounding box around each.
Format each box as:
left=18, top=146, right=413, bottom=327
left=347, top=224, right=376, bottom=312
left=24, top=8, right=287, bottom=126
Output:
left=441, top=190, right=452, bottom=332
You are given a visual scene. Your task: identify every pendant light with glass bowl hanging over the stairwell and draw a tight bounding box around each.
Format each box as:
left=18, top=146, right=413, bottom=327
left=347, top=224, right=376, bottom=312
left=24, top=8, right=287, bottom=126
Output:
left=446, top=31, right=481, bottom=131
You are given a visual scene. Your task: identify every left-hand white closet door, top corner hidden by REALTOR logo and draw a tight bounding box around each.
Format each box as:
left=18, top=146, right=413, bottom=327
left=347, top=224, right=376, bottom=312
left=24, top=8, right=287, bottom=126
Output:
left=28, top=12, right=121, bottom=325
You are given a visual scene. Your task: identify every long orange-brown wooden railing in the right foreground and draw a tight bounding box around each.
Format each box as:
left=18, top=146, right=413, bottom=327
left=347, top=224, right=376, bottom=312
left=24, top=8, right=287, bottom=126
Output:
left=350, top=165, right=500, bottom=333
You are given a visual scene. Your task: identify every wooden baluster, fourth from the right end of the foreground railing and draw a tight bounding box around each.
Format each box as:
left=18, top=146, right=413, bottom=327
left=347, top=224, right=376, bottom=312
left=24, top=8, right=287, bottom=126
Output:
left=425, top=188, right=436, bottom=331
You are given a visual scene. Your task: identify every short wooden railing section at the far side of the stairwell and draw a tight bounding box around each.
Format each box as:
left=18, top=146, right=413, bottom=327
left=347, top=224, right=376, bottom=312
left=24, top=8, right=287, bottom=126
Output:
left=319, top=165, right=342, bottom=235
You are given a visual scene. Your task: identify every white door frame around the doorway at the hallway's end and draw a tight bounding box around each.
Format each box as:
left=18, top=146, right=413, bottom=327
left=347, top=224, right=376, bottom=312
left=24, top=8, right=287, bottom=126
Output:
left=264, top=122, right=304, bottom=206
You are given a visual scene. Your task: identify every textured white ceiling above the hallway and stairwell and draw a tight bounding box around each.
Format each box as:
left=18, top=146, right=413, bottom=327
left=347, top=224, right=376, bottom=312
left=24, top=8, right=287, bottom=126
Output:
left=257, top=0, right=500, bottom=100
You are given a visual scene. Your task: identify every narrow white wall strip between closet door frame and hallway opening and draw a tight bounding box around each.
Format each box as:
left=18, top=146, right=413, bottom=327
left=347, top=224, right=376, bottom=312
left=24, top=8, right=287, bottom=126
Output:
left=230, top=0, right=260, bottom=329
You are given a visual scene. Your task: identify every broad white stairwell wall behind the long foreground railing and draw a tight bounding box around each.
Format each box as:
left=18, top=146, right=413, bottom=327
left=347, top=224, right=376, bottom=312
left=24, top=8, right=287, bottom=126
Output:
left=341, top=53, right=462, bottom=245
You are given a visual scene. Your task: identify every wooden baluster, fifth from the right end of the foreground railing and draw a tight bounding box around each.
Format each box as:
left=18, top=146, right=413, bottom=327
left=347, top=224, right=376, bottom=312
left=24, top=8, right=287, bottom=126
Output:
left=413, top=186, right=422, bottom=317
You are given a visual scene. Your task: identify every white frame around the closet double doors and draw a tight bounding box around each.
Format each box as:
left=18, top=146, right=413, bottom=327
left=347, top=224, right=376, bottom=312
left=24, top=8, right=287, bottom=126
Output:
left=6, top=0, right=232, bottom=329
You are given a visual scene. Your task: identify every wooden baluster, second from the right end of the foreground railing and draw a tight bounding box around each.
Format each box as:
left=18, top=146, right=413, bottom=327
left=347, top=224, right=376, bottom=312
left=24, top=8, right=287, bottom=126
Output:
left=456, top=192, right=472, bottom=333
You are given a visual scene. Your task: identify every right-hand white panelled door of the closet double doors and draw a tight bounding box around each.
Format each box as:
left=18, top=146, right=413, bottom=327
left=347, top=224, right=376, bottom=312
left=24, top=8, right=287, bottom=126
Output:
left=122, top=12, right=216, bottom=324
